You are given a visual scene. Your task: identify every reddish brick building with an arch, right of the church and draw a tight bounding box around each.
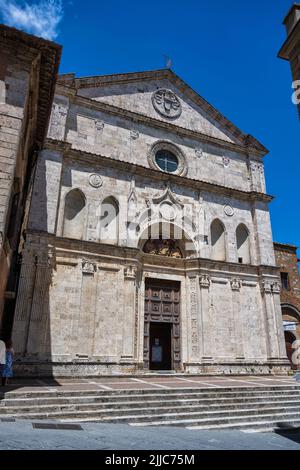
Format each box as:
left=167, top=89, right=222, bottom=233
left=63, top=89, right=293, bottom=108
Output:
left=274, top=243, right=300, bottom=369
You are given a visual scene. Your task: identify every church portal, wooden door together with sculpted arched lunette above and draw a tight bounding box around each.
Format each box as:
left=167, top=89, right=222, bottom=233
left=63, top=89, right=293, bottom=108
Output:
left=138, top=221, right=197, bottom=371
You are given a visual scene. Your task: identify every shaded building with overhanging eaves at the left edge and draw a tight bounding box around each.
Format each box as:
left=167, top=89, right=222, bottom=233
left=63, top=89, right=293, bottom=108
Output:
left=0, top=25, right=61, bottom=336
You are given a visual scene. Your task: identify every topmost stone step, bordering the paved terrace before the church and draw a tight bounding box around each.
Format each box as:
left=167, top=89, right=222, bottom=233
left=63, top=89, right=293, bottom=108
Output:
left=0, top=393, right=300, bottom=408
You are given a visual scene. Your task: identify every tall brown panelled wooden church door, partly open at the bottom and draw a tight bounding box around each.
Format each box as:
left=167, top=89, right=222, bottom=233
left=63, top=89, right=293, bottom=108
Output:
left=144, top=279, right=180, bottom=370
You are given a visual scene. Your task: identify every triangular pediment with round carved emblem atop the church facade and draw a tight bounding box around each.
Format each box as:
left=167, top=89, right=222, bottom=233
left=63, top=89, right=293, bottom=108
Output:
left=59, top=69, right=267, bottom=153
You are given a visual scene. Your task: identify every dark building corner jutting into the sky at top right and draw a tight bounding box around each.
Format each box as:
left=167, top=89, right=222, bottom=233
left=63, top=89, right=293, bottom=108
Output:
left=278, top=3, right=300, bottom=118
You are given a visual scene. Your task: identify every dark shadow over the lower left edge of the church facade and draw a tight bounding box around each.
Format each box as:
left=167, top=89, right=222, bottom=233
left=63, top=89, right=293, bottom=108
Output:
left=0, top=153, right=58, bottom=386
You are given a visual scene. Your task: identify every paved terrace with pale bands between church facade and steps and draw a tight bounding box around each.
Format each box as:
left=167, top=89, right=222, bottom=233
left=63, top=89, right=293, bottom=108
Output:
left=0, top=374, right=300, bottom=392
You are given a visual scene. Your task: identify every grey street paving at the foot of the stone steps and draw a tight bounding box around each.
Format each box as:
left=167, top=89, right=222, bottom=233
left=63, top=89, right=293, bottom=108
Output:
left=0, top=421, right=300, bottom=450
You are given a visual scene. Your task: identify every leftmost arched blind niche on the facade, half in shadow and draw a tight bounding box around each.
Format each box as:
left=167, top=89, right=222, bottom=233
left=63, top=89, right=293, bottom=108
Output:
left=63, top=189, right=86, bottom=240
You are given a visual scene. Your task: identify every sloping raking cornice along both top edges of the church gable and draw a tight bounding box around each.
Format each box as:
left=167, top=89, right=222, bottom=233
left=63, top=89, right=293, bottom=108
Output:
left=58, top=69, right=269, bottom=155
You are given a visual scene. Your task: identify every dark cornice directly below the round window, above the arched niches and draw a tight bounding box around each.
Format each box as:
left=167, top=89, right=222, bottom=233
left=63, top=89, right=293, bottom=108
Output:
left=45, top=138, right=273, bottom=206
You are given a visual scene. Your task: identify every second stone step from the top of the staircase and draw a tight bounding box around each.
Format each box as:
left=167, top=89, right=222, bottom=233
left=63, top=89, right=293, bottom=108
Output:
left=0, top=398, right=300, bottom=417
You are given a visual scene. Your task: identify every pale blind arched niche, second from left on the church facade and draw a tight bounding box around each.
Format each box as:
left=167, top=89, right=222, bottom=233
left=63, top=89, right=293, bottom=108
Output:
left=100, top=197, right=119, bottom=245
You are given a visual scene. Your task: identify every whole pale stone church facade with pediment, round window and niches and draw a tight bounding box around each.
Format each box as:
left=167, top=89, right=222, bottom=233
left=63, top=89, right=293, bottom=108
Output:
left=13, top=69, right=289, bottom=376
